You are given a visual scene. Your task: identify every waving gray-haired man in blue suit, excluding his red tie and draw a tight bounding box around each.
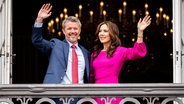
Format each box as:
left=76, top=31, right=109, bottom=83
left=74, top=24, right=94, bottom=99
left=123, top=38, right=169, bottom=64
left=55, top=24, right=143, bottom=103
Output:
left=32, top=3, right=90, bottom=103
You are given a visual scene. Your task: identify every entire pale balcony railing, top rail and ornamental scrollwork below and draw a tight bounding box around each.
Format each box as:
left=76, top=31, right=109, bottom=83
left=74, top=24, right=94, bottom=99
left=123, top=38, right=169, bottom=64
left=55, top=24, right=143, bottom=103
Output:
left=0, top=83, right=184, bottom=104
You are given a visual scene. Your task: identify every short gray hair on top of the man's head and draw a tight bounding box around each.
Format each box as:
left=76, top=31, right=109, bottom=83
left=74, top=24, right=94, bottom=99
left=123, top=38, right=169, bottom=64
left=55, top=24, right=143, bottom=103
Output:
left=62, top=16, right=82, bottom=29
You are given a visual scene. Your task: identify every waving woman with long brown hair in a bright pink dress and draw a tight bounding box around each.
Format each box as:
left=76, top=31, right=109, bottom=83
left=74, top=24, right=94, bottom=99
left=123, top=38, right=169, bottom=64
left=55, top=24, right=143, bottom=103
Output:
left=90, top=16, right=151, bottom=104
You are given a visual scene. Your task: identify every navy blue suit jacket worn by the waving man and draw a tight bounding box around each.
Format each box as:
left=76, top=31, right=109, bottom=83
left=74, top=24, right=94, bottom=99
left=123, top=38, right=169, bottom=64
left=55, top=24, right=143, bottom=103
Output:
left=32, top=27, right=90, bottom=84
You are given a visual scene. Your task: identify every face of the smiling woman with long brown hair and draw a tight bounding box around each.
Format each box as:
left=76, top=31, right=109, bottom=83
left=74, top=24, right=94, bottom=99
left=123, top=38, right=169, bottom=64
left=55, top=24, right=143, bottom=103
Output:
left=98, top=24, right=111, bottom=44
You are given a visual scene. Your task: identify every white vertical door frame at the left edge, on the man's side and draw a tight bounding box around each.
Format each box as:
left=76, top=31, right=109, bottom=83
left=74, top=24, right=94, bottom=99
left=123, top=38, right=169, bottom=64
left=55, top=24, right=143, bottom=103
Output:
left=0, top=0, right=12, bottom=84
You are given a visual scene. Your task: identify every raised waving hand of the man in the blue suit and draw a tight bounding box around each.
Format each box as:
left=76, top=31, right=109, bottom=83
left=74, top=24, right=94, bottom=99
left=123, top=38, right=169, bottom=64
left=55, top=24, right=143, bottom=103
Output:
left=36, top=3, right=52, bottom=23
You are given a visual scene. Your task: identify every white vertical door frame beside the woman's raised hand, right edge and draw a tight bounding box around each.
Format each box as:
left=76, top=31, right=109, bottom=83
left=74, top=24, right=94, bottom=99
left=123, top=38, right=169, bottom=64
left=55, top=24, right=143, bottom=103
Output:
left=173, top=0, right=182, bottom=83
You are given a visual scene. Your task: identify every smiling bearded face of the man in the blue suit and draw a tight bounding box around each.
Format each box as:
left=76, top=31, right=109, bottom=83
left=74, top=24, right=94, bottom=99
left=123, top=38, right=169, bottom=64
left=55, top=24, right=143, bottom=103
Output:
left=62, top=21, right=81, bottom=44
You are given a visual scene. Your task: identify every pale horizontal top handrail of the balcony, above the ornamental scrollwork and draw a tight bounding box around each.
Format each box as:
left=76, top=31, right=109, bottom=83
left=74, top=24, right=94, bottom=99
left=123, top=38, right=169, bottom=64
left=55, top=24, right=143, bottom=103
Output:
left=0, top=83, right=184, bottom=97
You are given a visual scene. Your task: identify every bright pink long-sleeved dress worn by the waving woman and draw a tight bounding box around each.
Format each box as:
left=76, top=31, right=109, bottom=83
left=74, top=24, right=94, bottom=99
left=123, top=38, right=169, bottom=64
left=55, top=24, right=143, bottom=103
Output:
left=90, top=42, right=147, bottom=104
